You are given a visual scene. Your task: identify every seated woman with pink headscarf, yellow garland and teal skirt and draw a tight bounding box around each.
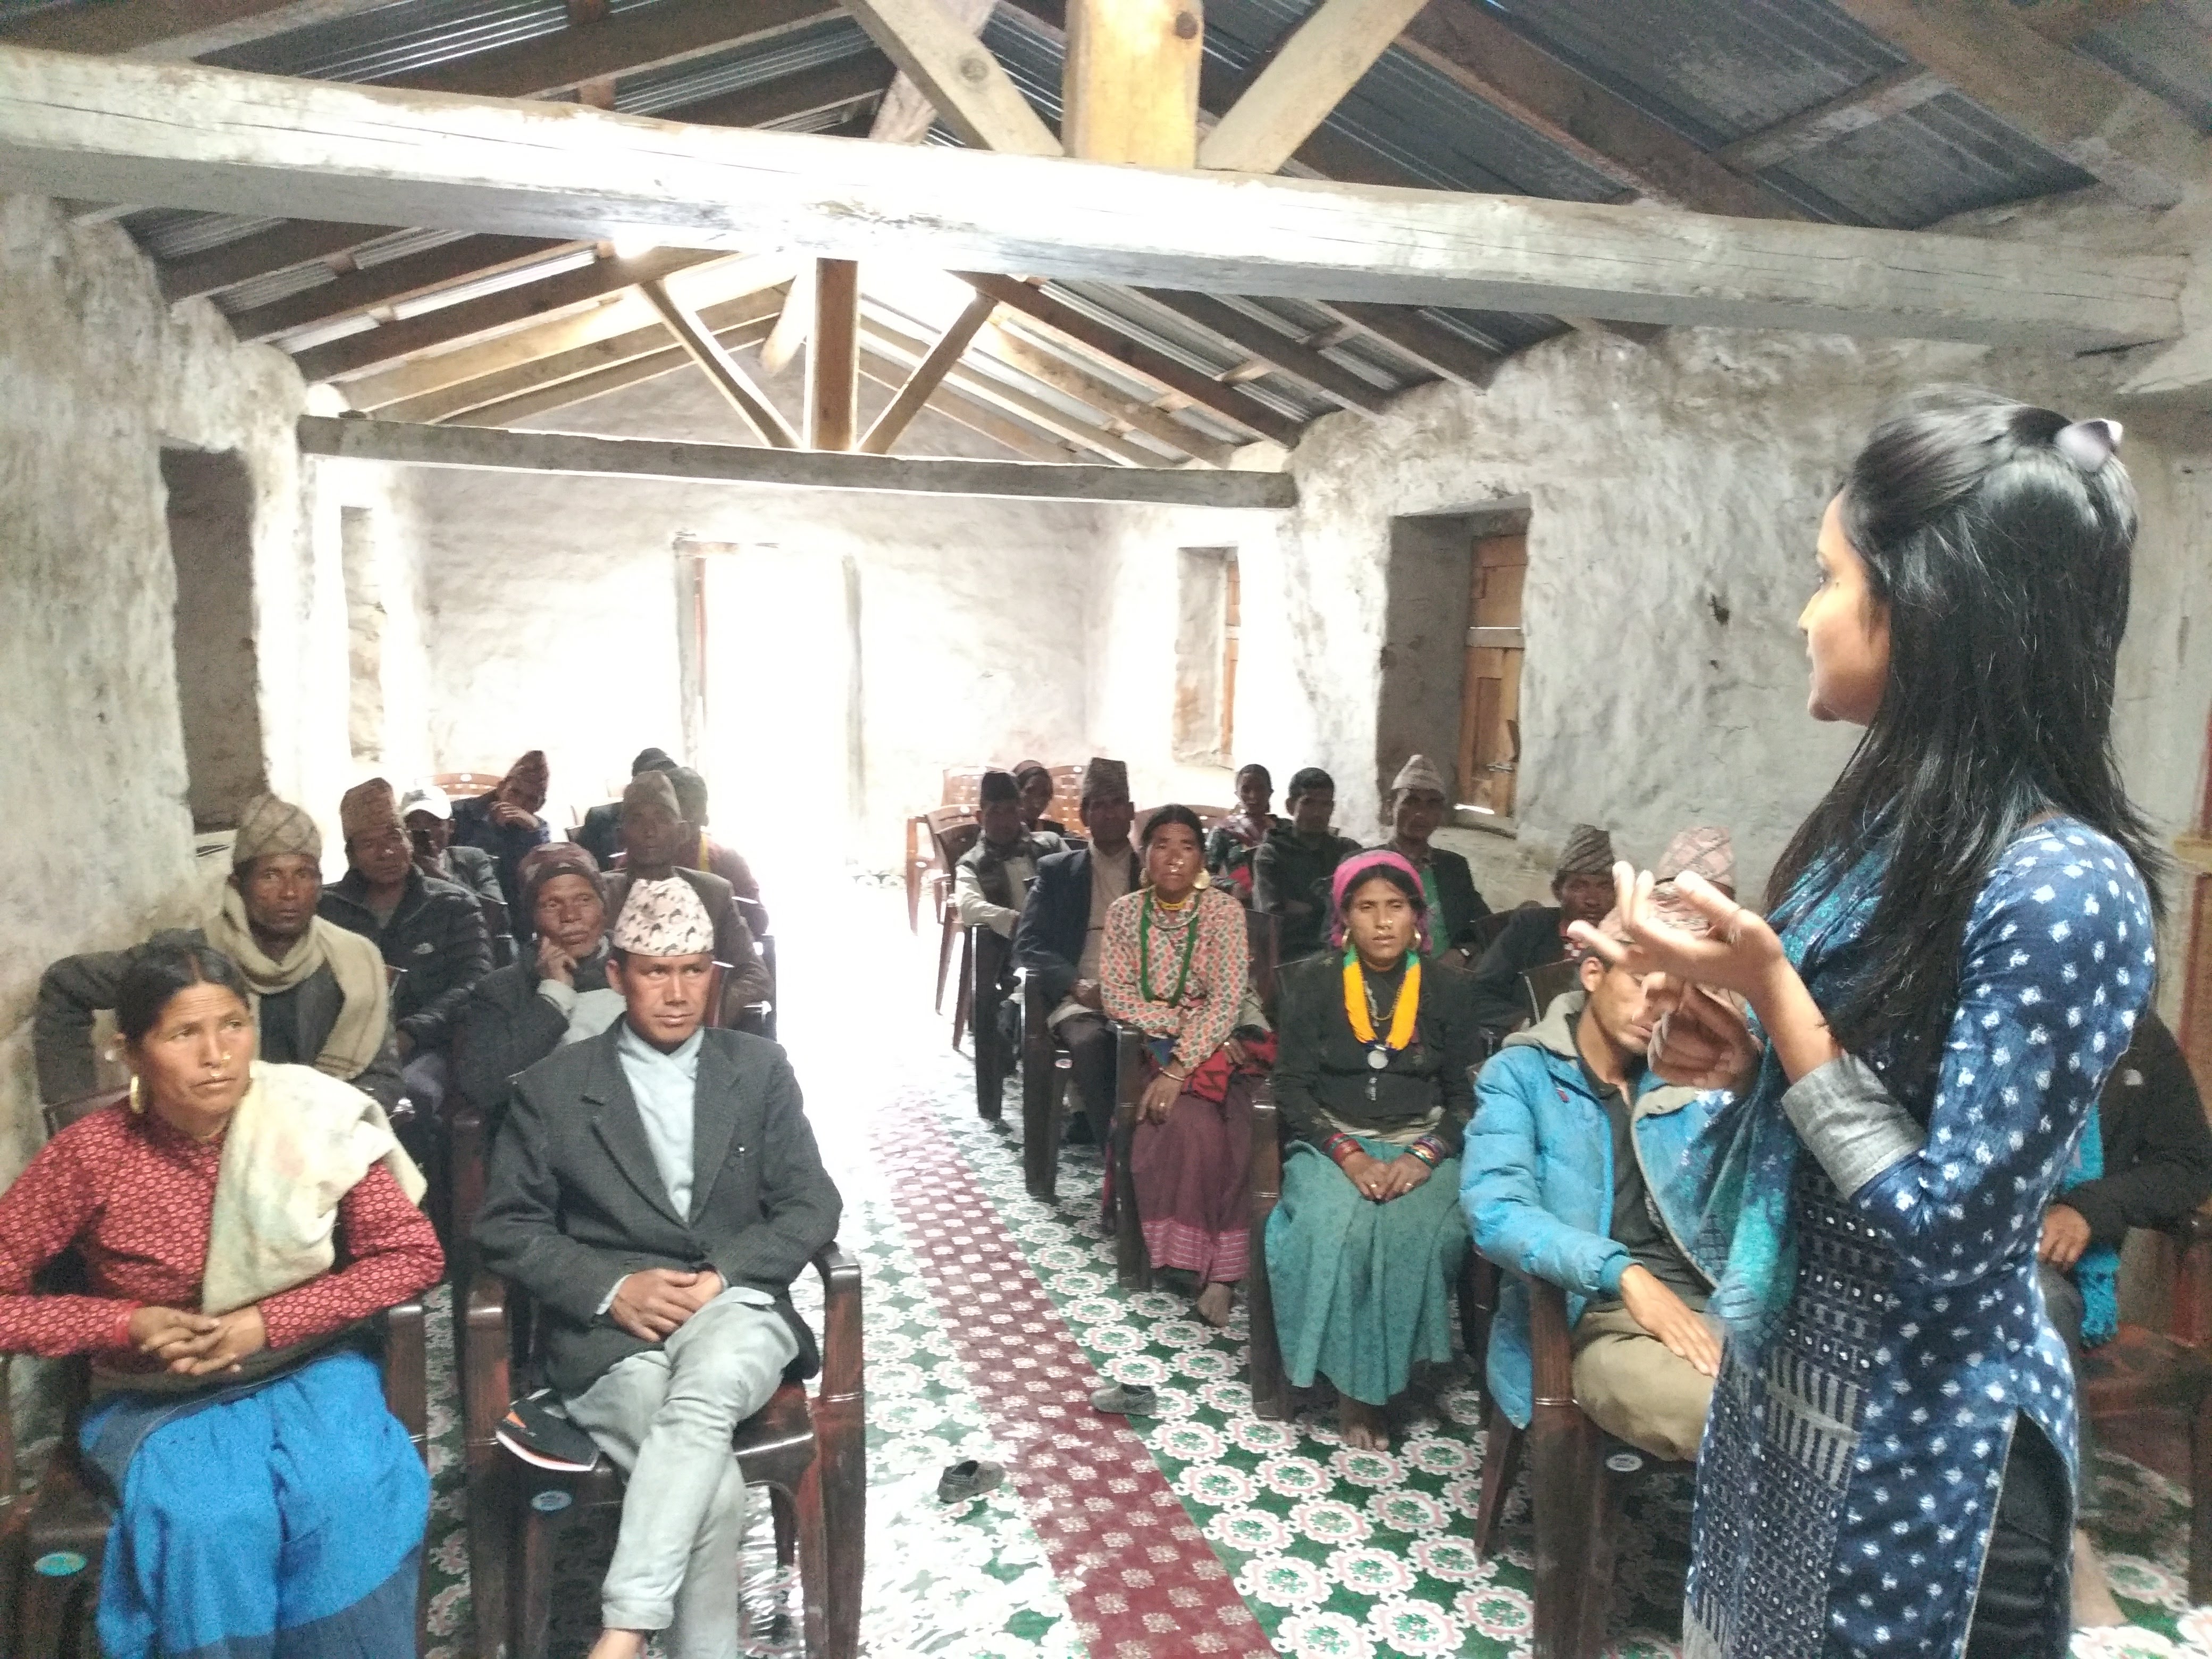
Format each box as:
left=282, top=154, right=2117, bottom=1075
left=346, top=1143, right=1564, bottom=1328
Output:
left=1268, top=849, right=1476, bottom=1447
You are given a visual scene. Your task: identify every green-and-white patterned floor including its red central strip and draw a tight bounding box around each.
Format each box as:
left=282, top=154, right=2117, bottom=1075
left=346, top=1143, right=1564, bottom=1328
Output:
left=416, top=889, right=2212, bottom=1659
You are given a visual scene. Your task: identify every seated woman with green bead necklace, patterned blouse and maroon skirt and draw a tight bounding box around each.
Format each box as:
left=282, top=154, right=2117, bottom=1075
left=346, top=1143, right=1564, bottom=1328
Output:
left=1100, top=807, right=1256, bottom=1325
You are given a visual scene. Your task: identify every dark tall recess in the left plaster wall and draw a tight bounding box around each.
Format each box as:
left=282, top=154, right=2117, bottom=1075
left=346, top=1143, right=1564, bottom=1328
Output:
left=162, top=447, right=267, bottom=830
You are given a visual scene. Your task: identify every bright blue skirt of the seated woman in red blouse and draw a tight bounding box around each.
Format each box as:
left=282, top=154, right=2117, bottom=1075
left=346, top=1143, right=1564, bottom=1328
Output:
left=80, top=1354, right=429, bottom=1659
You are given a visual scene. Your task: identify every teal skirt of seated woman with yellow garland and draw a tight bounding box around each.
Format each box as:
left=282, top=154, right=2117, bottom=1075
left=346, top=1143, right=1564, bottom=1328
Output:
left=1268, top=1135, right=1469, bottom=1405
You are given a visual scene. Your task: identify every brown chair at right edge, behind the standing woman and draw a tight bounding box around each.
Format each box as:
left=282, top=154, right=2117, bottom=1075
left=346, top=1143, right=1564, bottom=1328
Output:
left=2079, top=1210, right=2212, bottom=1602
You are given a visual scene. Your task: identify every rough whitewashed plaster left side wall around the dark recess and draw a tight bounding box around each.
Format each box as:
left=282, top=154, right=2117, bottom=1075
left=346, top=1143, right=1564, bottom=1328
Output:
left=0, top=197, right=345, bottom=1179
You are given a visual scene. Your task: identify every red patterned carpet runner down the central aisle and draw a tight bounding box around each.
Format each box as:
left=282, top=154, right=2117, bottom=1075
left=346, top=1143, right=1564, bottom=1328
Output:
left=876, top=1100, right=1274, bottom=1659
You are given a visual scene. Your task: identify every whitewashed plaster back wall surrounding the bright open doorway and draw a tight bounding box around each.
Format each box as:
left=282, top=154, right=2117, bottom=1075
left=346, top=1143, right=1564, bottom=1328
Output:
left=416, top=400, right=1097, bottom=867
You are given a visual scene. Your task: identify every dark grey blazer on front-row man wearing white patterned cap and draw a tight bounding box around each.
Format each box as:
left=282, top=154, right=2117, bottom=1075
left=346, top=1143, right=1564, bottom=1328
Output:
left=475, top=1020, right=845, bottom=1396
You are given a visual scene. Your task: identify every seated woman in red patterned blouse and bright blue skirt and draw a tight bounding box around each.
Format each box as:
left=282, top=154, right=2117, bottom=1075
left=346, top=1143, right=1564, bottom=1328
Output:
left=0, top=944, right=445, bottom=1659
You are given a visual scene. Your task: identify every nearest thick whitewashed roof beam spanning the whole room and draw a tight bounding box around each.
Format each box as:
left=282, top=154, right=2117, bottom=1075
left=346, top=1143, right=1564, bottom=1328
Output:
left=0, top=48, right=2188, bottom=351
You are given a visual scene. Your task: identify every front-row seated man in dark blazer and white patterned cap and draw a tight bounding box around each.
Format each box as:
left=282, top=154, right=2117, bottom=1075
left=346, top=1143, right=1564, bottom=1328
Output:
left=475, top=876, right=843, bottom=1659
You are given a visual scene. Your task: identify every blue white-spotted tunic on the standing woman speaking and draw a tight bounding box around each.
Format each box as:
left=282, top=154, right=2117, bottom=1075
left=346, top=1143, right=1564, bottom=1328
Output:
left=1683, top=818, right=2152, bottom=1659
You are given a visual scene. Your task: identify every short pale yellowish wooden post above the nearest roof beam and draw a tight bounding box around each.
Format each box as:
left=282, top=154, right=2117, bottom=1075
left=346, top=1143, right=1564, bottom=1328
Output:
left=1060, top=0, right=1205, bottom=168
